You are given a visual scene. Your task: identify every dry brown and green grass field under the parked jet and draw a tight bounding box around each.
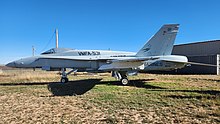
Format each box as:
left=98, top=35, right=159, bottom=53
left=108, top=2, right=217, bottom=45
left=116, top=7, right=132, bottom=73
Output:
left=0, top=70, right=220, bottom=123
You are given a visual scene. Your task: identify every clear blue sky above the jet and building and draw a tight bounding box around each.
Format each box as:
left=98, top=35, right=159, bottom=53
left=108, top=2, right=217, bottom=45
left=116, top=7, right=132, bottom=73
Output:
left=0, top=0, right=220, bottom=64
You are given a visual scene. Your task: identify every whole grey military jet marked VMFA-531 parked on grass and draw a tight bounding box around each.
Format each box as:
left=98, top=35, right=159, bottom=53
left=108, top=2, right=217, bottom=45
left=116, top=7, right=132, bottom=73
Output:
left=6, top=24, right=191, bottom=85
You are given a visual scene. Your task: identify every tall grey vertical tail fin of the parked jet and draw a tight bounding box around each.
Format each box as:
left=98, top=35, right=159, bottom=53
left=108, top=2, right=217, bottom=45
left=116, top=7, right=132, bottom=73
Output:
left=136, top=24, right=179, bottom=56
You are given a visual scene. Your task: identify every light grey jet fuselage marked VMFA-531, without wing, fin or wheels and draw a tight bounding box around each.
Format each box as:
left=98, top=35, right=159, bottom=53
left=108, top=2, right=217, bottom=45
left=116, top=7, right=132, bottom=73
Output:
left=7, top=50, right=187, bottom=72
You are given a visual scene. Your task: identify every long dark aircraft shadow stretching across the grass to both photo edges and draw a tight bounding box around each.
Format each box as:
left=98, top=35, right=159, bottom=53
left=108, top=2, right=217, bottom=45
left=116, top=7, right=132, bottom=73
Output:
left=0, top=79, right=217, bottom=99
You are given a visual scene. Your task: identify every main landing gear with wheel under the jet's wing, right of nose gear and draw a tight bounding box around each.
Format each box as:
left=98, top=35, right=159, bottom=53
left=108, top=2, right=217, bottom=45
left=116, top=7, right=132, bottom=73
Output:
left=112, top=71, right=130, bottom=86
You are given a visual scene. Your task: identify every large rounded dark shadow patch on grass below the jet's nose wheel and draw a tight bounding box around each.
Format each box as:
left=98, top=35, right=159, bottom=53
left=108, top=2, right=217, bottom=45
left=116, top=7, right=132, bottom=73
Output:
left=47, top=79, right=102, bottom=96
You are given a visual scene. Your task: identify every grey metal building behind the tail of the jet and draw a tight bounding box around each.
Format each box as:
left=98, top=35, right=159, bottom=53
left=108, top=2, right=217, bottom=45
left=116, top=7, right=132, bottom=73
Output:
left=172, top=40, right=220, bottom=75
